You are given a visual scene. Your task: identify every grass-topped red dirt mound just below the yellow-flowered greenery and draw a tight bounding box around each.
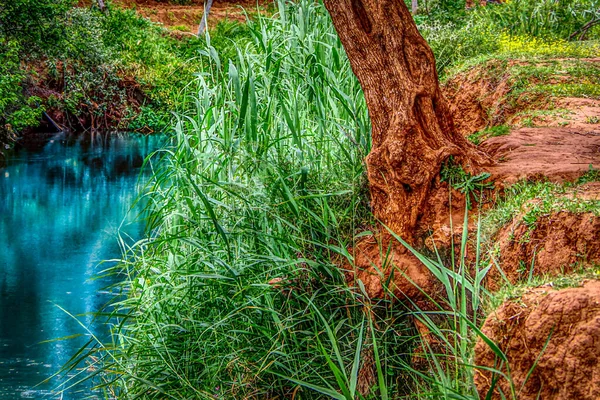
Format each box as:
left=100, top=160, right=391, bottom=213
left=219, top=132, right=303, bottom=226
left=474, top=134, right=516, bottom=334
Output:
left=442, top=58, right=600, bottom=135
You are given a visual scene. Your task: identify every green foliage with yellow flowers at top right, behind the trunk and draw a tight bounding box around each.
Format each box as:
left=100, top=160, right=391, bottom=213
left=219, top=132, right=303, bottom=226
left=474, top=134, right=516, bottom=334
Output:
left=415, top=0, right=600, bottom=78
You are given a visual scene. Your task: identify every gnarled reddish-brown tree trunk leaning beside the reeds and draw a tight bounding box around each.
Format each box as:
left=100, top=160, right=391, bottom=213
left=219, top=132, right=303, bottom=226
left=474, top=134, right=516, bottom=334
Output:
left=324, top=0, right=487, bottom=243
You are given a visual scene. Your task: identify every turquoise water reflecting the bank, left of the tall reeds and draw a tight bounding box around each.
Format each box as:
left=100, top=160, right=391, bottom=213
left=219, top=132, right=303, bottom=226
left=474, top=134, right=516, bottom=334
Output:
left=0, top=134, right=162, bottom=399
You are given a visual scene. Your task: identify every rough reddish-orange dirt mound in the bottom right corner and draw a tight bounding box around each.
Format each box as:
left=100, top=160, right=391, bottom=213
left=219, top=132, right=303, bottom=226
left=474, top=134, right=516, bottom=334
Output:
left=475, top=281, right=600, bottom=400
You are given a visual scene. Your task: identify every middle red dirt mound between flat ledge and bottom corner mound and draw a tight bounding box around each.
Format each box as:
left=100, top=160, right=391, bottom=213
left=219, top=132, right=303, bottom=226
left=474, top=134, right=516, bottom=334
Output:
left=486, top=212, right=600, bottom=289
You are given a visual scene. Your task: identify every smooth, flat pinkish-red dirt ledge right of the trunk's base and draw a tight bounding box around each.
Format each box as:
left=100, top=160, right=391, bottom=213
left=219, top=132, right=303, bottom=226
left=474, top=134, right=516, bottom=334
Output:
left=481, top=127, right=600, bottom=186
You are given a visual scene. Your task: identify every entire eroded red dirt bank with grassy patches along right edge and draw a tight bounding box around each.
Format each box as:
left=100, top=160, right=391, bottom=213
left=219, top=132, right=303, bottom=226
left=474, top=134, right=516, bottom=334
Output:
left=445, top=59, right=600, bottom=400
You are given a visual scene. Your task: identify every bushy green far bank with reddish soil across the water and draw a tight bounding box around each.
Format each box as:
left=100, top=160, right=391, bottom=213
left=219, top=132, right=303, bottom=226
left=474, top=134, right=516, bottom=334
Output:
left=0, top=0, right=255, bottom=154
